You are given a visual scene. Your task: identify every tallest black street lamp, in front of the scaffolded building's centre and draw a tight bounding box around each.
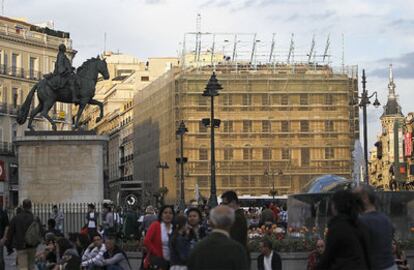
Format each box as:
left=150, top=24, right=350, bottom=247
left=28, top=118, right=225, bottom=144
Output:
left=201, top=72, right=223, bottom=207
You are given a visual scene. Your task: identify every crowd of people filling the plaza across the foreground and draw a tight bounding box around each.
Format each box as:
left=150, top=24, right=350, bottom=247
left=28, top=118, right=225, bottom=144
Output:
left=0, top=186, right=409, bottom=270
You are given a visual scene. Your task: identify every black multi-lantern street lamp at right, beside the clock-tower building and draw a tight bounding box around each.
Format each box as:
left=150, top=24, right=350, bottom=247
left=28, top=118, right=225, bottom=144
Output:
left=358, top=69, right=381, bottom=184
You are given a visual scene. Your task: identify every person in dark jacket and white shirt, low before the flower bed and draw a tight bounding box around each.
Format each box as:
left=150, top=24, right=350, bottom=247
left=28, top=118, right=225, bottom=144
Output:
left=257, top=238, right=282, bottom=270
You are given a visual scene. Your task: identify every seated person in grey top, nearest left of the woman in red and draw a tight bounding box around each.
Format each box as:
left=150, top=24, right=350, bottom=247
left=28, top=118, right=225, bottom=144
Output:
left=97, top=235, right=131, bottom=270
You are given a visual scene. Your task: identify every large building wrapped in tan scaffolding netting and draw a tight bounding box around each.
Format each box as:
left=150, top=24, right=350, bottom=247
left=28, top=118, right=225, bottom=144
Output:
left=134, top=32, right=359, bottom=204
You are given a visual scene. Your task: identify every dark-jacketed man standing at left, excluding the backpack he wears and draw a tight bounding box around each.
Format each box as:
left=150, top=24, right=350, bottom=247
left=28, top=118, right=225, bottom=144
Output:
left=7, top=199, right=36, bottom=269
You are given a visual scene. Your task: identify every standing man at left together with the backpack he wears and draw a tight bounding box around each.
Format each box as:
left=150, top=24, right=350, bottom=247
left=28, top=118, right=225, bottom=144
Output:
left=7, top=199, right=41, bottom=269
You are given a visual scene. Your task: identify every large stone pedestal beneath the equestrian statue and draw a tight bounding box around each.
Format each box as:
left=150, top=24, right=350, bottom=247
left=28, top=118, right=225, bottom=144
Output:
left=16, top=131, right=108, bottom=203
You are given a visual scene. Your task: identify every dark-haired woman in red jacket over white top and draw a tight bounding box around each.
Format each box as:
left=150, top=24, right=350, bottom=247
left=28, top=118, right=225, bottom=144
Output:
left=144, top=205, right=175, bottom=270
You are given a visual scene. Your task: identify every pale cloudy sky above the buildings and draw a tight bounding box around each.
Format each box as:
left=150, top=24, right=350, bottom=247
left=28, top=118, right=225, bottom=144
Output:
left=4, top=0, right=414, bottom=148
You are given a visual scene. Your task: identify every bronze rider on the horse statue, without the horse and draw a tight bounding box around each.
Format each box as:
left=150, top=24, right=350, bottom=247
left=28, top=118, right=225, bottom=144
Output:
left=45, top=44, right=79, bottom=103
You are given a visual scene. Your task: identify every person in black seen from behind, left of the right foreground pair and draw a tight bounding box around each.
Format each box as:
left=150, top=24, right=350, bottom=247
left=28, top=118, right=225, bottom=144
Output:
left=317, top=190, right=372, bottom=270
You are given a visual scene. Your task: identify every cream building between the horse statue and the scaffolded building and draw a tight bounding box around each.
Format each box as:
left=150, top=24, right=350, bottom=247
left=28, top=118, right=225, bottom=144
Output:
left=82, top=51, right=178, bottom=204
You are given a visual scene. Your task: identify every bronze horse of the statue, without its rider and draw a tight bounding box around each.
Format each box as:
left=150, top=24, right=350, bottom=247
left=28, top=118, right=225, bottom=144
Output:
left=17, top=57, right=109, bottom=130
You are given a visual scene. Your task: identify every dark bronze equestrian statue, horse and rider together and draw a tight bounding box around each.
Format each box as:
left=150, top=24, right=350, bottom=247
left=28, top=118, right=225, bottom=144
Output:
left=17, top=44, right=109, bottom=130
